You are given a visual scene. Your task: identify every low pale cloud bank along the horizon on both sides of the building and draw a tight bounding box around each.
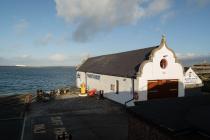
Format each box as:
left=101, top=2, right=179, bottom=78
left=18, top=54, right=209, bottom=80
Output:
left=0, top=52, right=210, bottom=66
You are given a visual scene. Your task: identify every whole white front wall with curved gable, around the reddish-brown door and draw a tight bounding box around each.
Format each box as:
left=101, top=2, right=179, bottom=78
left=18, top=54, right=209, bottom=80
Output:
left=138, top=44, right=184, bottom=101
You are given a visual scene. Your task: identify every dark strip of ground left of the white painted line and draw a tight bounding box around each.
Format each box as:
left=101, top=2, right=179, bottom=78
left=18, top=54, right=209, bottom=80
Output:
left=0, top=95, right=25, bottom=140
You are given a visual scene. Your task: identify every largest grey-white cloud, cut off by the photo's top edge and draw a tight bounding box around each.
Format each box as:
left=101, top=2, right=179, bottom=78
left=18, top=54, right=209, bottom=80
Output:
left=55, top=0, right=171, bottom=42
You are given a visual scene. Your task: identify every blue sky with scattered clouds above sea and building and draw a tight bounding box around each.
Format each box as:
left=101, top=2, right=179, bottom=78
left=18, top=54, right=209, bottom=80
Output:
left=0, top=0, right=210, bottom=66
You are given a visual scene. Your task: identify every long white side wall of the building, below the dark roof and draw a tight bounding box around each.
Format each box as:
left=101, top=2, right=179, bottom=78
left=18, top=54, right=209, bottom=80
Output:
left=77, top=71, right=135, bottom=106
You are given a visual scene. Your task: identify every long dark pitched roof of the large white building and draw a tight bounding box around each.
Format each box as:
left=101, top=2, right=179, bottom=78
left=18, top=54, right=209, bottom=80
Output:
left=77, top=46, right=158, bottom=78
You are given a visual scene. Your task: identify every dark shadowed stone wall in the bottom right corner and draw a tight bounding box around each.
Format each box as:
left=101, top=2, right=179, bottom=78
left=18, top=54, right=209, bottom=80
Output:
left=128, top=113, right=209, bottom=140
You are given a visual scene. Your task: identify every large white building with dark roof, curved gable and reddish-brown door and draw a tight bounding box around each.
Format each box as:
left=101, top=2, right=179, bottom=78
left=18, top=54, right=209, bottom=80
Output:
left=76, top=37, right=185, bottom=106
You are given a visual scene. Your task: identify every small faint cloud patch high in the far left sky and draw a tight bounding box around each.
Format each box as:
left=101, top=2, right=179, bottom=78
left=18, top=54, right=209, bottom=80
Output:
left=14, top=19, right=29, bottom=35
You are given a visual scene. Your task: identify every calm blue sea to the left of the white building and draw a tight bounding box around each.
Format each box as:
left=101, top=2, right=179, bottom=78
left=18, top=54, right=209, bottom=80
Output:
left=0, top=66, right=76, bottom=94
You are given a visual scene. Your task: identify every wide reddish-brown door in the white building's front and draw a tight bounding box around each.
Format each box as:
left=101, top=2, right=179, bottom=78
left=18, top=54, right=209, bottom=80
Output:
left=148, top=80, right=178, bottom=99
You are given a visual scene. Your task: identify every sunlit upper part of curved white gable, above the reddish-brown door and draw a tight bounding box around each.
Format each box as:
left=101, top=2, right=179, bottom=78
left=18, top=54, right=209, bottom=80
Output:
left=141, top=45, right=183, bottom=81
